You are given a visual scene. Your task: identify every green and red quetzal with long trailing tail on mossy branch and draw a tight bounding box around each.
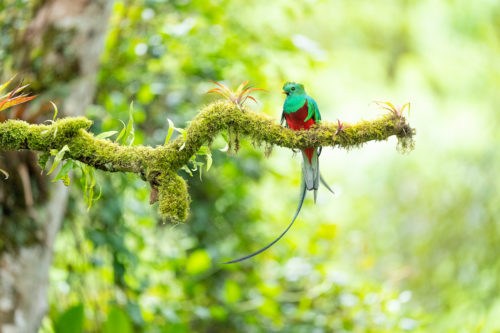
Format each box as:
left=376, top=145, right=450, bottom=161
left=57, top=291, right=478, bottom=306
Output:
left=224, top=82, right=334, bottom=264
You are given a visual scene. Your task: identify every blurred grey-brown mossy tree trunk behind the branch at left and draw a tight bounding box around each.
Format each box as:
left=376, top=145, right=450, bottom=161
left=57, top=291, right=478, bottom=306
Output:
left=0, top=0, right=113, bottom=332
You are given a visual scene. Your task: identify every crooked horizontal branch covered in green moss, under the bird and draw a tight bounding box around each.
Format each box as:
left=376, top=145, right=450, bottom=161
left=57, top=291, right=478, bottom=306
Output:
left=0, top=102, right=415, bottom=221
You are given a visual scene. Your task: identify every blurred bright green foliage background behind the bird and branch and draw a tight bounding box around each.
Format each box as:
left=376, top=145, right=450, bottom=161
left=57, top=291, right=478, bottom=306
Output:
left=0, top=0, right=500, bottom=332
